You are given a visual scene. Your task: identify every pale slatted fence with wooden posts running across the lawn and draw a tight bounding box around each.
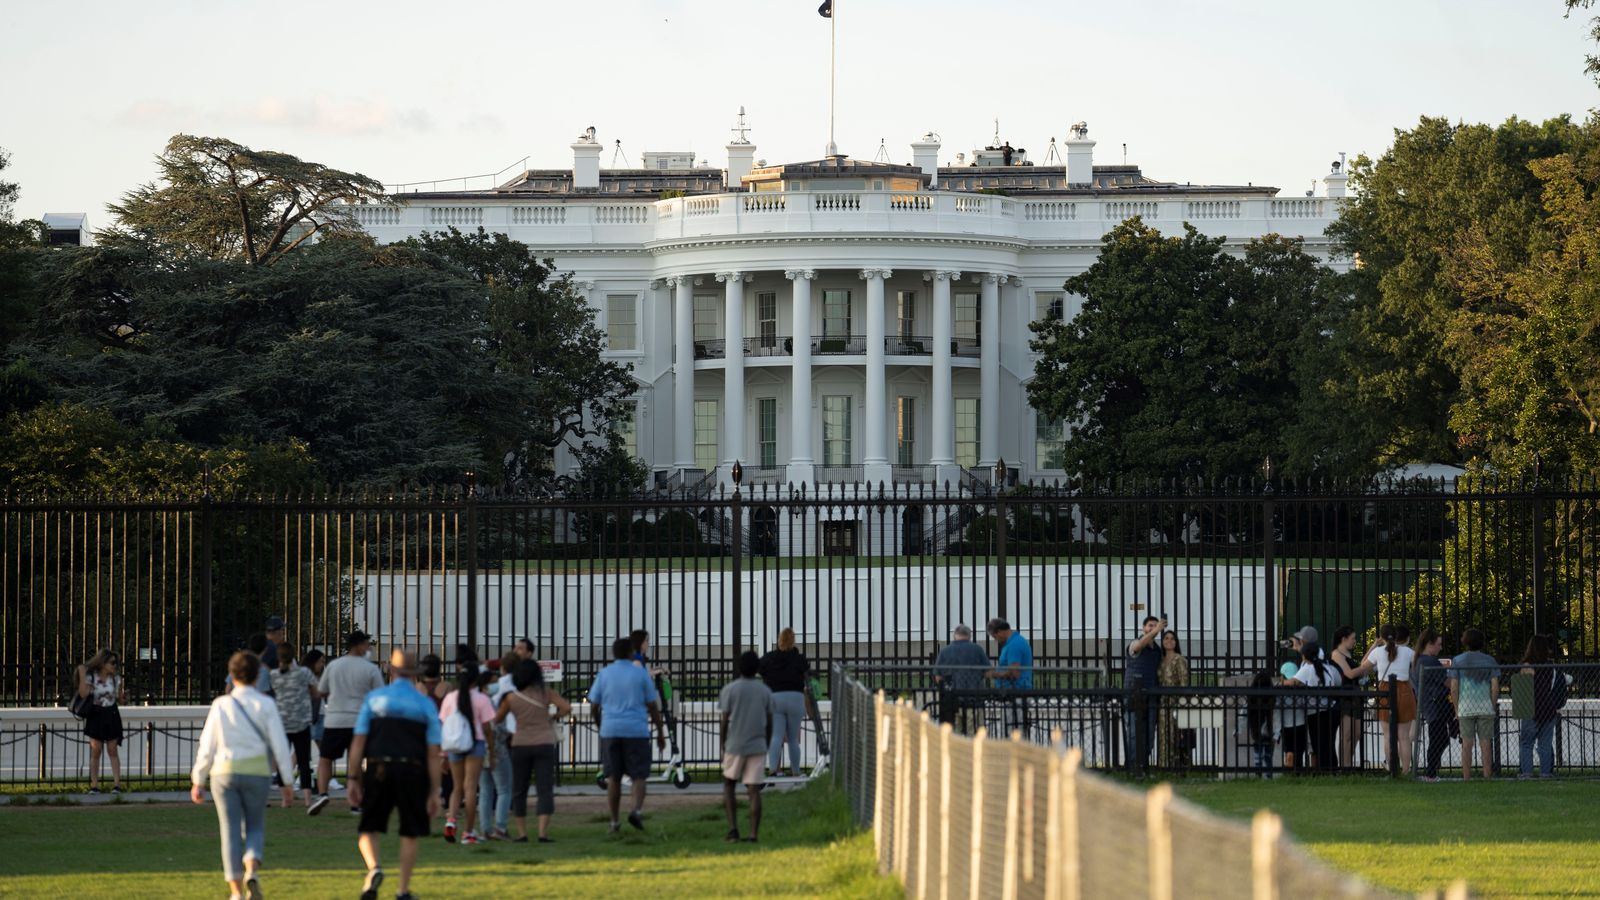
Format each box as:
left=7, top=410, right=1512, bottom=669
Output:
left=834, top=666, right=1466, bottom=900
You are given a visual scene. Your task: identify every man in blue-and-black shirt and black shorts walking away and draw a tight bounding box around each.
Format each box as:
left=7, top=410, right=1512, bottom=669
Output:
left=349, top=649, right=438, bottom=900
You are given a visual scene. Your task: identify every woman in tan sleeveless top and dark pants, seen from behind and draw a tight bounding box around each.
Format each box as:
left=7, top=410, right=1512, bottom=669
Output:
left=494, top=660, right=573, bottom=844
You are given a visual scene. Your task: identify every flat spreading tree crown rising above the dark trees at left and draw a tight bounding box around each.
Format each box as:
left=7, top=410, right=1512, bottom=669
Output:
left=109, top=135, right=387, bottom=264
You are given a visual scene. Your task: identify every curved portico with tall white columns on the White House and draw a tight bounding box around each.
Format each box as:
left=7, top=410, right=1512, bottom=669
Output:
left=658, top=253, right=1026, bottom=485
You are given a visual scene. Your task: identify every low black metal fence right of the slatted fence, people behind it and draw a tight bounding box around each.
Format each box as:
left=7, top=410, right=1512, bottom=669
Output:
left=832, top=663, right=1600, bottom=777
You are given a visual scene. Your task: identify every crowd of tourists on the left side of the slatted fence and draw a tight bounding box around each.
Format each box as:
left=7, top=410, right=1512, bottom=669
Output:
left=74, top=617, right=814, bottom=900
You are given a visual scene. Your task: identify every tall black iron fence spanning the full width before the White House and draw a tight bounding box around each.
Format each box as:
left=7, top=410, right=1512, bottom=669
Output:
left=0, top=476, right=1600, bottom=706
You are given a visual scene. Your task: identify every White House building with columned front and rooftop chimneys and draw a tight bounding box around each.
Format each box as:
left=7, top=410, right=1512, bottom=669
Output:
left=355, top=123, right=1346, bottom=506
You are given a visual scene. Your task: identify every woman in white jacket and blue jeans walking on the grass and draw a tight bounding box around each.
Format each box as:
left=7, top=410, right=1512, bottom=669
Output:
left=189, top=650, right=294, bottom=900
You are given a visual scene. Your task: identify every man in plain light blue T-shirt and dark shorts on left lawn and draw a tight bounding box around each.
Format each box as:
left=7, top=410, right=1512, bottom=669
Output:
left=589, top=637, right=667, bottom=833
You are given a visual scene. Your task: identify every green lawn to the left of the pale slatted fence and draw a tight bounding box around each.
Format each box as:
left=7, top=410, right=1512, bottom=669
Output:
left=0, top=785, right=901, bottom=900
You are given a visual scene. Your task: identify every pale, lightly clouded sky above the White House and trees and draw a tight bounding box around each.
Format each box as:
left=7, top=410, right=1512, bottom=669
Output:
left=0, top=0, right=1600, bottom=216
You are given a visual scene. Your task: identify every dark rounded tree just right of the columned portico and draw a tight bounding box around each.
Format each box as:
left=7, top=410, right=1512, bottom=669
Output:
left=1029, top=219, right=1360, bottom=479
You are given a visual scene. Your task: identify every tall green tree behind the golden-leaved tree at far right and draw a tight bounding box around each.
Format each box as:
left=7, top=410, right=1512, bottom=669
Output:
left=1328, top=117, right=1582, bottom=463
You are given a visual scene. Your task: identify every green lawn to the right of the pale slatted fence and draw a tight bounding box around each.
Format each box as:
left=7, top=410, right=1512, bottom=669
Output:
left=1176, top=778, right=1600, bottom=897
